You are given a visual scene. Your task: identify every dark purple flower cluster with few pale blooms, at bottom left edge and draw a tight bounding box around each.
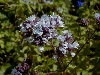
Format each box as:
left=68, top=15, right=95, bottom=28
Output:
left=11, top=59, right=31, bottom=75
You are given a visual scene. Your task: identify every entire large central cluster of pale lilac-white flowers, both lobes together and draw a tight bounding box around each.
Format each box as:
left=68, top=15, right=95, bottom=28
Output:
left=20, top=15, right=79, bottom=55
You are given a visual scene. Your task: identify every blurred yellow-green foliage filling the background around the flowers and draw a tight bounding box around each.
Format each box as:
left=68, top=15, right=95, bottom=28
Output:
left=0, top=0, right=100, bottom=75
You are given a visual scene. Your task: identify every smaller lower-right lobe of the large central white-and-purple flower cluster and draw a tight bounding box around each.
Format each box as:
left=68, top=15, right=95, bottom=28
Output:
left=57, top=30, right=79, bottom=55
